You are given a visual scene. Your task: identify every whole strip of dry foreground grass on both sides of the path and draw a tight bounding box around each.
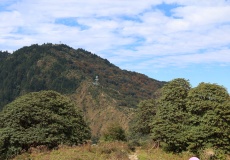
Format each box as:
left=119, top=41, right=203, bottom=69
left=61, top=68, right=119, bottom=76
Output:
left=13, top=142, right=230, bottom=160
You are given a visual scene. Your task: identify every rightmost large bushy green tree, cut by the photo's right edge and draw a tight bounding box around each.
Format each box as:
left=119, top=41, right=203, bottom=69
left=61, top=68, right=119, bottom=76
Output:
left=187, top=83, right=230, bottom=153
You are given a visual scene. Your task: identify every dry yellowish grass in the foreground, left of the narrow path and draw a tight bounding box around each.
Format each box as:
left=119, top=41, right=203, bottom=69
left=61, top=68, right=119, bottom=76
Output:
left=14, top=142, right=129, bottom=160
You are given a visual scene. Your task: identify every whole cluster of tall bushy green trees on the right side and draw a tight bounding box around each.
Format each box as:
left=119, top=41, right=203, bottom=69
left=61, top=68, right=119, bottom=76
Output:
left=131, top=78, right=230, bottom=159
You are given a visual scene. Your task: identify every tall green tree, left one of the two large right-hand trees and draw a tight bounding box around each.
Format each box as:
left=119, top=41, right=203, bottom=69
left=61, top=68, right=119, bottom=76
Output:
left=152, top=78, right=191, bottom=152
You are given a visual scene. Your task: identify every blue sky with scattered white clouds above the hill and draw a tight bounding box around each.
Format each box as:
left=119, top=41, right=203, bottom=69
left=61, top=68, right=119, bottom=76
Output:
left=0, top=0, right=230, bottom=92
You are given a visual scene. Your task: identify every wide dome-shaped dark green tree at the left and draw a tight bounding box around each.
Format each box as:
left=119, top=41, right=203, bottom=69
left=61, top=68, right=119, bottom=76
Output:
left=0, top=91, right=90, bottom=158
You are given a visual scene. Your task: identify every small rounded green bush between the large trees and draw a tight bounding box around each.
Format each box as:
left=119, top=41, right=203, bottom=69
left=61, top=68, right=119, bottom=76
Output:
left=102, top=123, right=126, bottom=141
